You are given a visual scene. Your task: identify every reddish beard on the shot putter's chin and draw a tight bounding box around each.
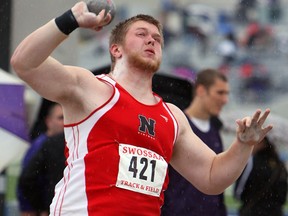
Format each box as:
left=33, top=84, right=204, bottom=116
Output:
left=128, top=53, right=160, bottom=73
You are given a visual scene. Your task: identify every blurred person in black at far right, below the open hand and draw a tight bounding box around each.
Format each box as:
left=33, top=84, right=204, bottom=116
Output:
left=234, top=137, right=287, bottom=216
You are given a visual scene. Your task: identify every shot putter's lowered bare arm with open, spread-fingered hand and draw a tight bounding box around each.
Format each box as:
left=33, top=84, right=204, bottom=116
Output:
left=169, top=105, right=272, bottom=194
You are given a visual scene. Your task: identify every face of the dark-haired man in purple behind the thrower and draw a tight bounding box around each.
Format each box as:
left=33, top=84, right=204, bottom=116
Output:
left=203, top=79, right=229, bottom=116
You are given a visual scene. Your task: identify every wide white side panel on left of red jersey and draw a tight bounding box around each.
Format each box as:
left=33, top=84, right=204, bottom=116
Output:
left=50, top=79, right=120, bottom=216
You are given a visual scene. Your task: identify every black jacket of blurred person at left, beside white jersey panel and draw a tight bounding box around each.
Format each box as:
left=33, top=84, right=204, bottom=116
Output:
left=19, top=133, right=66, bottom=216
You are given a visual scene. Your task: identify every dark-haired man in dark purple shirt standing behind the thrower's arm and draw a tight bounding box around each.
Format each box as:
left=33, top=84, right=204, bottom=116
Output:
left=161, top=69, right=230, bottom=216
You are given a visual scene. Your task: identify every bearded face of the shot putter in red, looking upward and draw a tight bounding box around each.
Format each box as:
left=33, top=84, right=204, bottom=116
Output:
left=123, top=21, right=162, bottom=72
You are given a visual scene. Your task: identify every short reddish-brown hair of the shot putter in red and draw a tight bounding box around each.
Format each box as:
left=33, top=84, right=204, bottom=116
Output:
left=109, top=14, right=164, bottom=69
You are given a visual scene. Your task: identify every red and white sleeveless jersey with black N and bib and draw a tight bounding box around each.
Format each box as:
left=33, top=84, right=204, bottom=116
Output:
left=50, top=75, right=178, bottom=216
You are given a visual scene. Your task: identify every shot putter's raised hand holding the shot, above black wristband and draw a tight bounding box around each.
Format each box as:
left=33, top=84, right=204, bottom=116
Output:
left=71, top=1, right=111, bottom=31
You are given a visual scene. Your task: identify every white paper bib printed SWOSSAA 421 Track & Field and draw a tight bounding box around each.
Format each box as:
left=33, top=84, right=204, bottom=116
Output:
left=116, top=144, right=168, bottom=197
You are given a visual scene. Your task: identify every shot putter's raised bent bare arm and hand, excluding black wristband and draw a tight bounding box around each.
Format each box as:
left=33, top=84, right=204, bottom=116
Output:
left=11, top=2, right=111, bottom=102
